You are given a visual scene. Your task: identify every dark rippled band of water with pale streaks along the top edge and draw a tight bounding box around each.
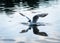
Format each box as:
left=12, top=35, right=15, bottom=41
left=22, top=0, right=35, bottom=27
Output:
left=0, top=0, right=57, bottom=15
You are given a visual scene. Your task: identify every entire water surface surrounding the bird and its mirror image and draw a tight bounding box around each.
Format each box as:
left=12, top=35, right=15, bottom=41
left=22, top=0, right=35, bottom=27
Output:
left=0, top=0, right=60, bottom=43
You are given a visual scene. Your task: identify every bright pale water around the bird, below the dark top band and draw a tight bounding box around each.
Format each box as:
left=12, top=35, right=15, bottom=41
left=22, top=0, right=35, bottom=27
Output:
left=0, top=0, right=60, bottom=43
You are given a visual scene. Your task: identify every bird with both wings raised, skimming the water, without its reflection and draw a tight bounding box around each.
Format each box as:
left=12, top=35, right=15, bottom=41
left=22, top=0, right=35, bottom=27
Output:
left=19, top=13, right=48, bottom=26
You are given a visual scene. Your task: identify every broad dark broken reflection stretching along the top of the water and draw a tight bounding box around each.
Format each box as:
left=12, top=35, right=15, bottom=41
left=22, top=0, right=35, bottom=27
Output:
left=0, top=0, right=57, bottom=13
